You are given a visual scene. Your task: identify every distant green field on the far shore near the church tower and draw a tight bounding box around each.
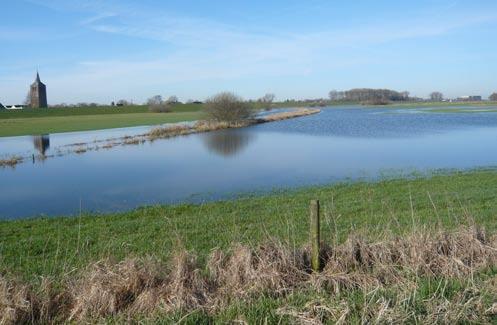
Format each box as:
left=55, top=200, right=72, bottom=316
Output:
left=0, top=104, right=202, bottom=137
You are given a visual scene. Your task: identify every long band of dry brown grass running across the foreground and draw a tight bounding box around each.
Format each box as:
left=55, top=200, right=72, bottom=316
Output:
left=0, top=227, right=497, bottom=324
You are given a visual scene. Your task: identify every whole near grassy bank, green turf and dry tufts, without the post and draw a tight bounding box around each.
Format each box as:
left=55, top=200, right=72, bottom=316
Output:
left=0, top=171, right=497, bottom=323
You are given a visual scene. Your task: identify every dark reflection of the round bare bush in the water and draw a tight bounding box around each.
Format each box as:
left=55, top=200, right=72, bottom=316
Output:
left=203, top=129, right=255, bottom=157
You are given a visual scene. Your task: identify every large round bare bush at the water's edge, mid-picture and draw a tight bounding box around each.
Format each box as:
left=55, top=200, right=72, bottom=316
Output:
left=204, top=92, right=253, bottom=122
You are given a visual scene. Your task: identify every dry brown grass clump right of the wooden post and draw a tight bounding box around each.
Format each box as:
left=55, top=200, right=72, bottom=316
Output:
left=327, top=228, right=497, bottom=281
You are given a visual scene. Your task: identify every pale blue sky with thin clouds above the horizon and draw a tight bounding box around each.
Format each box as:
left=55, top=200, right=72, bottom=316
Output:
left=0, top=0, right=497, bottom=104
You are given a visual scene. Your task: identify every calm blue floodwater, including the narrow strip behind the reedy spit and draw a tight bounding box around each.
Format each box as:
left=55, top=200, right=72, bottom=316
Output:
left=0, top=107, right=497, bottom=219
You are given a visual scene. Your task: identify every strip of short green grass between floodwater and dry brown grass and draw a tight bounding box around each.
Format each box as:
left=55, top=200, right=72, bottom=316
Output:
left=0, top=171, right=497, bottom=281
